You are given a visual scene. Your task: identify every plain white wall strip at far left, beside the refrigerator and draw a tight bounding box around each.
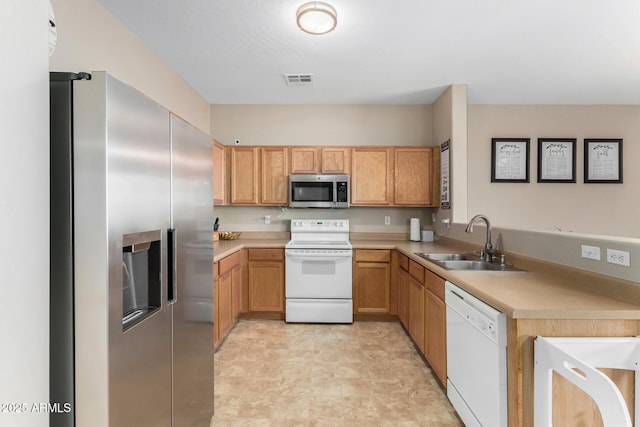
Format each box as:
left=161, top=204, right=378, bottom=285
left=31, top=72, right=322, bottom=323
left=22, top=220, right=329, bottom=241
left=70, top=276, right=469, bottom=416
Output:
left=0, top=0, right=49, bottom=427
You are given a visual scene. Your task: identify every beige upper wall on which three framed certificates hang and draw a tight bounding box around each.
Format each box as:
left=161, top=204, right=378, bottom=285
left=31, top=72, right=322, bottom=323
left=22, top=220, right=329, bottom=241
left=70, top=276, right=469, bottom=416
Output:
left=468, top=105, right=640, bottom=238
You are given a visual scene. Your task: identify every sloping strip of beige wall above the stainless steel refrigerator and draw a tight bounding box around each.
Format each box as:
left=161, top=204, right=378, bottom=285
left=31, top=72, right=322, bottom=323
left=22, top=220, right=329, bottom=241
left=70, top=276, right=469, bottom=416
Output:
left=51, top=0, right=211, bottom=134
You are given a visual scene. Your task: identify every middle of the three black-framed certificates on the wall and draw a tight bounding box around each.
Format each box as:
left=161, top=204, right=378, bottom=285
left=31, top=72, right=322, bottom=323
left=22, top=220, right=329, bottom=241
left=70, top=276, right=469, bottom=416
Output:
left=538, top=138, right=577, bottom=183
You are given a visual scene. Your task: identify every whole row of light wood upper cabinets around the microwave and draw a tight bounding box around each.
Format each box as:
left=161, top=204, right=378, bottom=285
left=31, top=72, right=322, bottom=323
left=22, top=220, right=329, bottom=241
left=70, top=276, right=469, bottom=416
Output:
left=222, top=142, right=440, bottom=207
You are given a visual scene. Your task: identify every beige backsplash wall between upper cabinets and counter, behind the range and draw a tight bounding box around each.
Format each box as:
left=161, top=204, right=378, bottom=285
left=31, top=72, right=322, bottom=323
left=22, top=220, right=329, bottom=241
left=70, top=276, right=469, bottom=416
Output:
left=213, top=206, right=434, bottom=233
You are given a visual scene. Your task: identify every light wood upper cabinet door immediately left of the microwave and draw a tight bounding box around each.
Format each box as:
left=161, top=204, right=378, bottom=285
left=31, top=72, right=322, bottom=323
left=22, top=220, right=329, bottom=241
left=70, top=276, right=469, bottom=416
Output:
left=260, top=147, right=289, bottom=206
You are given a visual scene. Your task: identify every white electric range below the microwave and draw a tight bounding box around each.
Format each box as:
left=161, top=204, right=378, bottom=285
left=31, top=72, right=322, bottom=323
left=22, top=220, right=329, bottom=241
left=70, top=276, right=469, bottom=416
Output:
left=285, top=219, right=353, bottom=323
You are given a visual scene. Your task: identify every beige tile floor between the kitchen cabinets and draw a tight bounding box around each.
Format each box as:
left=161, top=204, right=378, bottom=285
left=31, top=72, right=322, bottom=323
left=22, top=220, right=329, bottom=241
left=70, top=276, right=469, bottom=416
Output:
left=211, top=320, right=463, bottom=427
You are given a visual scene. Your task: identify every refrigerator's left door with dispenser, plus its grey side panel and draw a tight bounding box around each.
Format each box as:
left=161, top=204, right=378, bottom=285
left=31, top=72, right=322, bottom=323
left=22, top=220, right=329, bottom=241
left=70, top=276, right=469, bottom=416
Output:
left=74, top=72, right=171, bottom=427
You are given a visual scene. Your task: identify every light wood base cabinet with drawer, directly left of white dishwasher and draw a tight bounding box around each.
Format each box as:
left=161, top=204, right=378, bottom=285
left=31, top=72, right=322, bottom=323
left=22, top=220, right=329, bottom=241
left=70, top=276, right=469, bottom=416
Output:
left=425, top=270, right=447, bottom=387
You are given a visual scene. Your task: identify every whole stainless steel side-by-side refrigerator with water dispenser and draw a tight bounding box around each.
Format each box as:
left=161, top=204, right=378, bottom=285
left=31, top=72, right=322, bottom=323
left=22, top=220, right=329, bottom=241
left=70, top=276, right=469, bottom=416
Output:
left=50, top=72, right=213, bottom=427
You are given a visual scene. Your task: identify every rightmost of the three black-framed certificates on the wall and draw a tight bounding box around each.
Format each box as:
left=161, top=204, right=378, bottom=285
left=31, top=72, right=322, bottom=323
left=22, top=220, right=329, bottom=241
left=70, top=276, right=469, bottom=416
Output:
left=584, top=138, right=622, bottom=184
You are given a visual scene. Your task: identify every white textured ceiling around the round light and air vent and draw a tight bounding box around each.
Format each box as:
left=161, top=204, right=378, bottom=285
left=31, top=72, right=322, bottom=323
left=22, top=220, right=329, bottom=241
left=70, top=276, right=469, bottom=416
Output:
left=99, top=0, right=640, bottom=104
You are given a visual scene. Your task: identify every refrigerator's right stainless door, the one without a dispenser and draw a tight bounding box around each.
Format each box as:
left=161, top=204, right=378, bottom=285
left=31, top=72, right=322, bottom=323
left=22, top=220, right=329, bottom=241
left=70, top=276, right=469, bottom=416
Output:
left=171, top=115, right=213, bottom=426
